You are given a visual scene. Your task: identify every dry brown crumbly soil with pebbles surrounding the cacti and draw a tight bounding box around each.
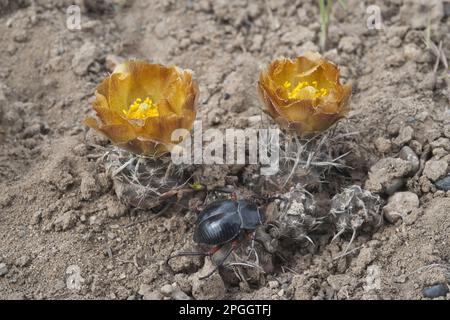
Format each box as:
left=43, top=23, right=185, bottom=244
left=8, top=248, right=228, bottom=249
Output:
left=0, top=0, right=450, bottom=299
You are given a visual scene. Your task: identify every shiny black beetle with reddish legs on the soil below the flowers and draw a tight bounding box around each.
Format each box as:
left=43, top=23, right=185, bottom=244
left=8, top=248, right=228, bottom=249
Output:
left=167, top=199, right=264, bottom=279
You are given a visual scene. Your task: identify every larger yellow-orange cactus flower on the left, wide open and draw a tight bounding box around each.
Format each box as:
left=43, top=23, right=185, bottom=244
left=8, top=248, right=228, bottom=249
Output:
left=85, top=60, right=198, bottom=155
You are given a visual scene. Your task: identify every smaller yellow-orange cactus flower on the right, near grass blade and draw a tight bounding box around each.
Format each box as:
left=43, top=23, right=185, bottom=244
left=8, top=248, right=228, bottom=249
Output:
left=258, top=52, right=352, bottom=137
